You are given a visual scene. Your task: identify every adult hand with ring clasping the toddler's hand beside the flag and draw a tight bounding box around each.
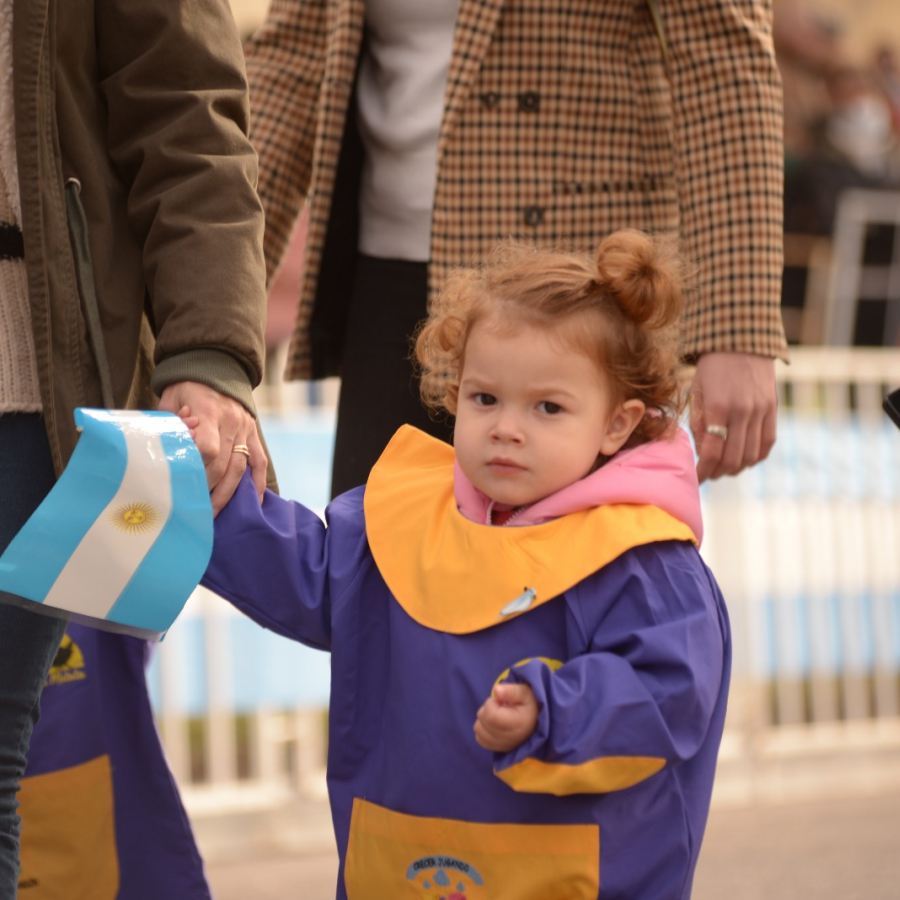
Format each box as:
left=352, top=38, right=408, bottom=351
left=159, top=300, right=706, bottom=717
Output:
left=159, top=381, right=269, bottom=516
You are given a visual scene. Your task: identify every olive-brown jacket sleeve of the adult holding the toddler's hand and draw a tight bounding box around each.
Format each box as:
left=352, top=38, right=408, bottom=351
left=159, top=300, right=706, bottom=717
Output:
left=95, top=0, right=266, bottom=409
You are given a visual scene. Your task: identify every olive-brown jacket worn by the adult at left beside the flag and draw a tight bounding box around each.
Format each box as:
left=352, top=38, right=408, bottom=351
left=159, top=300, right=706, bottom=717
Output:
left=13, top=0, right=265, bottom=470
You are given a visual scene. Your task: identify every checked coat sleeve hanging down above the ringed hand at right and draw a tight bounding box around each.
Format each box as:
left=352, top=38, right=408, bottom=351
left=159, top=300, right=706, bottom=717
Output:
left=658, top=0, right=787, bottom=359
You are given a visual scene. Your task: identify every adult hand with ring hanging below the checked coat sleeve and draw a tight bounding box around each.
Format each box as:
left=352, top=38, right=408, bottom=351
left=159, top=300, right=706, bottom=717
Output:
left=691, top=353, right=778, bottom=481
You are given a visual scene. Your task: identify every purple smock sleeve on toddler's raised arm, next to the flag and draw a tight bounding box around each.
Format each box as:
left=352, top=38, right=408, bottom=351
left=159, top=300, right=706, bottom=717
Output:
left=202, top=472, right=365, bottom=650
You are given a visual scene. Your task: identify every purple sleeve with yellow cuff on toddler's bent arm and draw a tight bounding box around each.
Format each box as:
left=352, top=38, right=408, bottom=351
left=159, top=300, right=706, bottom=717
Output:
left=494, top=543, right=730, bottom=795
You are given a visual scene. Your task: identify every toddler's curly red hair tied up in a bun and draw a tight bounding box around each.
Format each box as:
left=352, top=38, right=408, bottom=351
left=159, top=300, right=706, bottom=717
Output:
left=415, top=231, right=687, bottom=446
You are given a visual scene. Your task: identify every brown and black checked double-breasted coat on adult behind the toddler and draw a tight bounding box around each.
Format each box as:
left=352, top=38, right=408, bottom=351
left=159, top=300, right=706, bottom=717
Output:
left=247, top=0, right=786, bottom=378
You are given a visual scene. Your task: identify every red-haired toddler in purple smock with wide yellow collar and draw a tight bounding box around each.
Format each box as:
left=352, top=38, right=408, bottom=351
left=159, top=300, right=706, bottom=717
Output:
left=199, top=232, right=730, bottom=900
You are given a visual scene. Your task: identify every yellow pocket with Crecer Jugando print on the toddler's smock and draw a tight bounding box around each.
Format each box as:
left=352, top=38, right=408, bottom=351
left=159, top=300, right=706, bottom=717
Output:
left=344, top=799, right=600, bottom=900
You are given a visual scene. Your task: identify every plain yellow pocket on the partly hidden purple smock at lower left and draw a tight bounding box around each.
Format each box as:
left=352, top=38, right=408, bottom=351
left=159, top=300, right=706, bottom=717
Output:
left=19, top=756, right=119, bottom=900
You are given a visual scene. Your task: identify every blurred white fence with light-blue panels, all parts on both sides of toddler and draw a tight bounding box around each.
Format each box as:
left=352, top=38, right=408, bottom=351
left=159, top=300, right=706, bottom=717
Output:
left=151, top=349, right=900, bottom=813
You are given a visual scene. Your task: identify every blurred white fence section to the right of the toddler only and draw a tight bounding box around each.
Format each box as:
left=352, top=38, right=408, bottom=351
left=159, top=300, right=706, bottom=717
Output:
left=703, top=348, right=900, bottom=797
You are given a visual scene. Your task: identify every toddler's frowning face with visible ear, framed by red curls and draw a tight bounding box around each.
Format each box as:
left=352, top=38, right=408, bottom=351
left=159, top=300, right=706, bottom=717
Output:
left=453, top=322, right=644, bottom=506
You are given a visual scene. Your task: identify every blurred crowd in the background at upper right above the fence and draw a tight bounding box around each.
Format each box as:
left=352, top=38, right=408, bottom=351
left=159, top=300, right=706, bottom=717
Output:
left=775, top=0, right=900, bottom=344
